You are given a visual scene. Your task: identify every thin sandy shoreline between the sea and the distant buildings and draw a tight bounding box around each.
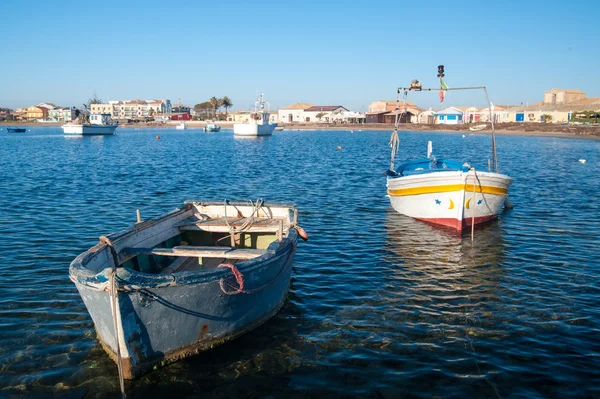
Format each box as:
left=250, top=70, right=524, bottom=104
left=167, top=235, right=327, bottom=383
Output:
left=0, top=121, right=600, bottom=140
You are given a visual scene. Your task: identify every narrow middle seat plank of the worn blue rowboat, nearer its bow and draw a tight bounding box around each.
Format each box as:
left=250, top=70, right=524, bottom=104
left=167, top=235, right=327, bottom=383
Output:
left=121, top=246, right=267, bottom=260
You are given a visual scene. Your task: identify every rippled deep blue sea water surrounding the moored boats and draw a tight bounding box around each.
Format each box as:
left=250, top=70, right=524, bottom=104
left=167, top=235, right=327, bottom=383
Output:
left=0, top=128, right=600, bottom=398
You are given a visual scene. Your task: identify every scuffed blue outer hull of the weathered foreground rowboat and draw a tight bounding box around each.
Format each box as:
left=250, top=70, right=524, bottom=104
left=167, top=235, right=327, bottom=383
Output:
left=70, top=216, right=298, bottom=379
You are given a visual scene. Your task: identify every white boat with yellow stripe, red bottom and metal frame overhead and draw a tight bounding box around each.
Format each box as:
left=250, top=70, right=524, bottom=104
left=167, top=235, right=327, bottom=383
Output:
left=387, top=65, right=512, bottom=231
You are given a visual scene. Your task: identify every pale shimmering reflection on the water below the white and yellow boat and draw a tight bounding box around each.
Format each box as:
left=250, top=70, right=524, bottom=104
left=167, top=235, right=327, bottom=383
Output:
left=382, top=209, right=505, bottom=316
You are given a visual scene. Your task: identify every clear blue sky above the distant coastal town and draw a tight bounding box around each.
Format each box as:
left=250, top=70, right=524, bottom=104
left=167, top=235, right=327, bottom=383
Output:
left=0, top=0, right=600, bottom=111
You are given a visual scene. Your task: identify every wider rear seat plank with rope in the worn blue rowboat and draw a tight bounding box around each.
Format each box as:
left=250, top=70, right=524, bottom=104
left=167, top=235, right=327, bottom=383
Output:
left=177, top=217, right=282, bottom=233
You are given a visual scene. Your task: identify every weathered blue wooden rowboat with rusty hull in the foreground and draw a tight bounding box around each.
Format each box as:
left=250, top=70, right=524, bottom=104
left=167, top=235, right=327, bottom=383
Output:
left=69, top=200, right=306, bottom=379
